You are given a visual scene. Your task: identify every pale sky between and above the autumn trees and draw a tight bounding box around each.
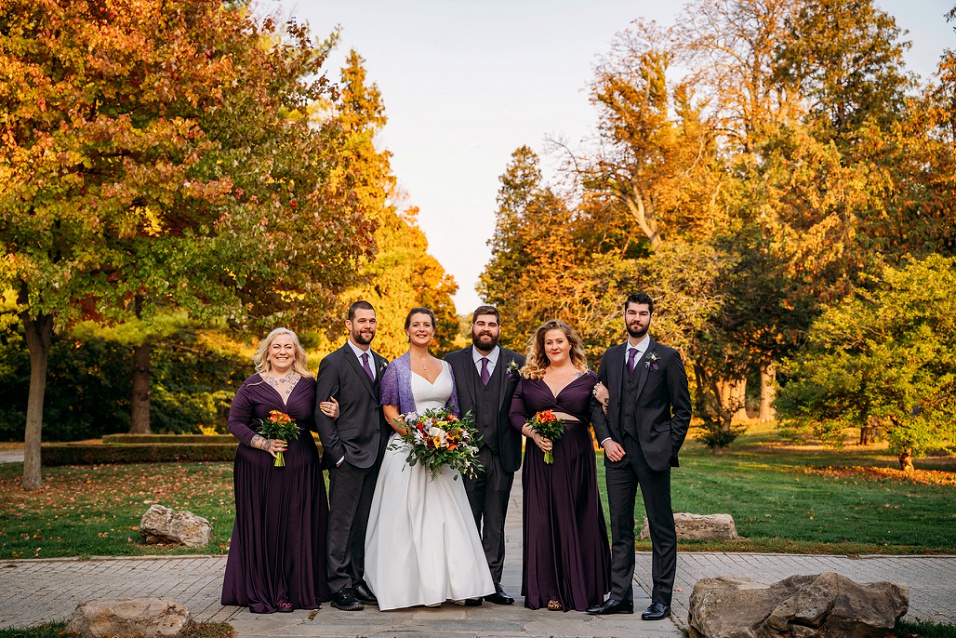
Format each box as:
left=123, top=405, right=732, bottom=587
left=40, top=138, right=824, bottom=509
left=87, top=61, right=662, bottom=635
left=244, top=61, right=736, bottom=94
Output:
left=258, top=0, right=956, bottom=314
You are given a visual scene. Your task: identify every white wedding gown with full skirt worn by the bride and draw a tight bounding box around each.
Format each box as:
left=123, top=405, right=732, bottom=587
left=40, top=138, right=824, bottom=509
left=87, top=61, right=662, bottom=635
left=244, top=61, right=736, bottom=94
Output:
left=365, top=361, right=495, bottom=609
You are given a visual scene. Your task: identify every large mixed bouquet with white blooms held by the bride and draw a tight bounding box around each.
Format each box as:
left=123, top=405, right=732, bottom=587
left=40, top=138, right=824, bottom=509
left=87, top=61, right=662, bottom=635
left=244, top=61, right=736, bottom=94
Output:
left=399, top=408, right=482, bottom=479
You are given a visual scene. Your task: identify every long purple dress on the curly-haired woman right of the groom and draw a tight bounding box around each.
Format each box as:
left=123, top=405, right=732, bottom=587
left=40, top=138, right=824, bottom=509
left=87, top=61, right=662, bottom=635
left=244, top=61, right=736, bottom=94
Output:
left=510, top=372, right=611, bottom=611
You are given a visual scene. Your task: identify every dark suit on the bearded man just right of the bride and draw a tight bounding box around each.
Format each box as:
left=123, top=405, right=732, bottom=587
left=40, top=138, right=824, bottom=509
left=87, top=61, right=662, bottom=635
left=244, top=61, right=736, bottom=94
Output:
left=445, top=346, right=525, bottom=585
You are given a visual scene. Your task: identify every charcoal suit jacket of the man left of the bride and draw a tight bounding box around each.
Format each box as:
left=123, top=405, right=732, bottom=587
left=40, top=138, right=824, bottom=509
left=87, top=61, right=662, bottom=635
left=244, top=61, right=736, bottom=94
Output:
left=315, top=343, right=389, bottom=468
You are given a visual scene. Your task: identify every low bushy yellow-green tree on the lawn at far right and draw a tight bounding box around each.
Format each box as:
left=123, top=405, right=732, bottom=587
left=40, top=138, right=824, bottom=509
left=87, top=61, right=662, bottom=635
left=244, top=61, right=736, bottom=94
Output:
left=777, top=255, right=956, bottom=470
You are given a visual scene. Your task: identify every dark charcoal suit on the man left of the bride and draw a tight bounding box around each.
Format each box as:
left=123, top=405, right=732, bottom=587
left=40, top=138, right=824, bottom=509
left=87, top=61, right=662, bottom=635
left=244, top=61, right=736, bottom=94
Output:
left=315, top=343, right=391, bottom=593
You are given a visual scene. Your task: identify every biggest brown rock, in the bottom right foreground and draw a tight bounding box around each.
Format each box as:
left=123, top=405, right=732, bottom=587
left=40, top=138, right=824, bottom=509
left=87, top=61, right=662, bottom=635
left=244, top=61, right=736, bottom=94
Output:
left=687, top=572, right=909, bottom=638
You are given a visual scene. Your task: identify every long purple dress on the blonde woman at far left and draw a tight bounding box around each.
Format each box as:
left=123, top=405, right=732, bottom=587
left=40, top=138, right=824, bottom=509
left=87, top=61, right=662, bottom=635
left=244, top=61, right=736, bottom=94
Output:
left=222, top=374, right=332, bottom=614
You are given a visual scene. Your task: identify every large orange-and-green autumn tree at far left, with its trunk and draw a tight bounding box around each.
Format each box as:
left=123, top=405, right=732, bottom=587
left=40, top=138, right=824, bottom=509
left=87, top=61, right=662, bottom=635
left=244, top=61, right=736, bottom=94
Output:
left=0, top=0, right=371, bottom=488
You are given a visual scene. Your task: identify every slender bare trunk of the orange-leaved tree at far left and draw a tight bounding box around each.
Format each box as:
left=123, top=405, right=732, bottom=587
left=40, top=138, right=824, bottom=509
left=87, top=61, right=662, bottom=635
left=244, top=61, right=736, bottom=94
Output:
left=20, top=312, right=53, bottom=490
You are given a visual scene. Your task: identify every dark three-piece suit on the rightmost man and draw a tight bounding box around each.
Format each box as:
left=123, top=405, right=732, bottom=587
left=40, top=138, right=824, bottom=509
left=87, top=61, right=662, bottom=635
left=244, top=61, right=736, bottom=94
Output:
left=592, top=339, right=691, bottom=606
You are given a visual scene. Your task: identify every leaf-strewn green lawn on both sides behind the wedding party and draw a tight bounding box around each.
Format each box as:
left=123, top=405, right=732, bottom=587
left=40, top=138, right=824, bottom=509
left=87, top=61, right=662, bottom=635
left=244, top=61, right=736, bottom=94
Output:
left=0, top=432, right=956, bottom=559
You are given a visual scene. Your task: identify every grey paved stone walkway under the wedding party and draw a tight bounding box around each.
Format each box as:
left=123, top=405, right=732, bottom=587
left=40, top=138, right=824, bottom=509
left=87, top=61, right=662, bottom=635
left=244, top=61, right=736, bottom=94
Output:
left=0, top=452, right=956, bottom=638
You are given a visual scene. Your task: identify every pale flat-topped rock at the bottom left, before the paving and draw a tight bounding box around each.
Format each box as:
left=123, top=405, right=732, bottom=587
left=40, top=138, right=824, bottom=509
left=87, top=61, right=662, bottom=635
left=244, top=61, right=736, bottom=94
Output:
left=66, top=598, right=192, bottom=638
